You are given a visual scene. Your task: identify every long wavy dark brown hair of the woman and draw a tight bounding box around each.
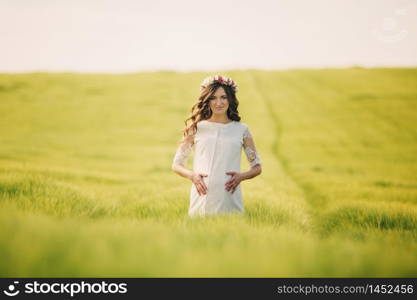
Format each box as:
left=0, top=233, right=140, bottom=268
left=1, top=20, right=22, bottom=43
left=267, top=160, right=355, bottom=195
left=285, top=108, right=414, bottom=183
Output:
left=183, top=82, right=240, bottom=139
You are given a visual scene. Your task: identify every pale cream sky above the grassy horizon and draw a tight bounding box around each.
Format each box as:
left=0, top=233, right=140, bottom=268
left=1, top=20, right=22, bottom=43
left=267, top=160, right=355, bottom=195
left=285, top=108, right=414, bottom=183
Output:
left=0, top=0, right=417, bottom=73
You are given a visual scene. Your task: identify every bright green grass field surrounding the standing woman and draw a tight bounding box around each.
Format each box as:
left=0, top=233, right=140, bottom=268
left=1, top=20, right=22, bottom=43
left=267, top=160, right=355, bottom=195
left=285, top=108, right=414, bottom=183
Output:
left=0, top=68, right=417, bottom=277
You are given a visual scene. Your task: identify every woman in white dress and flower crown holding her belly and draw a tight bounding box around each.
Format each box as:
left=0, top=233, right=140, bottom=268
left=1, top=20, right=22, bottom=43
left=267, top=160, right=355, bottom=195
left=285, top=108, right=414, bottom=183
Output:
left=172, top=75, right=262, bottom=216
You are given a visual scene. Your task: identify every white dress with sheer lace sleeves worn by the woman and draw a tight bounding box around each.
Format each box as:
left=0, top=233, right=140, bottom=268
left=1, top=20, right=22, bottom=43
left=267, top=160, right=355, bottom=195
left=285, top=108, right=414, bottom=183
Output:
left=173, top=120, right=261, bottom=216
